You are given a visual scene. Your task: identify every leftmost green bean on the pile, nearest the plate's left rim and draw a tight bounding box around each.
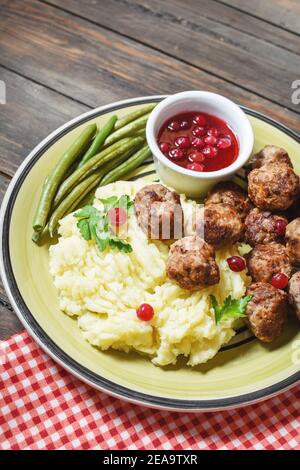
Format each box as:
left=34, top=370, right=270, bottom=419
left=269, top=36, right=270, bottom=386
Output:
left=33, top=124, right=97, bottom=232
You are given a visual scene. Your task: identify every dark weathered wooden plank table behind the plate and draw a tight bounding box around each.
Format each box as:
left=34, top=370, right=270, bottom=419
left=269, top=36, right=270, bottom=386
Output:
left=0, top=0, right=300, bottom=339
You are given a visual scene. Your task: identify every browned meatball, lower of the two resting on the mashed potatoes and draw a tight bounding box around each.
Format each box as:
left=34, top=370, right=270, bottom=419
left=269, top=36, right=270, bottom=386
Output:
left=167, top=235, right=220, bottom=291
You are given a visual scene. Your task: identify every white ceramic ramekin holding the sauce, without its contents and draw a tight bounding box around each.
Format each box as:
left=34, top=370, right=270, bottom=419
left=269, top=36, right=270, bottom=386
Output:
left=146, top=91, right=254, bottom=197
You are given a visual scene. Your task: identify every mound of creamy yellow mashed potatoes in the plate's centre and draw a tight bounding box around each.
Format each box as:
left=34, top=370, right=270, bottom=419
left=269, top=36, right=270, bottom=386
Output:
left=50, top=181, right=249, bottom=366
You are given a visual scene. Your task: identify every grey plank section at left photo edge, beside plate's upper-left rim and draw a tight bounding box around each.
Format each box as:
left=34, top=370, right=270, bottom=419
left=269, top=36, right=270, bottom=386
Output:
left=0, top=66, right=89, bottom=176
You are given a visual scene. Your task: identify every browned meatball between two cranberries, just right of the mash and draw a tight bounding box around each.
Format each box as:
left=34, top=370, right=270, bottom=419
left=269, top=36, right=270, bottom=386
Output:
left=246, top=243, right=292, bottom=282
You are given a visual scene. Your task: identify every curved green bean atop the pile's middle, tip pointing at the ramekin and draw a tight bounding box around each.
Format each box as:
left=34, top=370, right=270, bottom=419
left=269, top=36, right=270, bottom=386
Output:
left=54, top=137, right=144, bottom=207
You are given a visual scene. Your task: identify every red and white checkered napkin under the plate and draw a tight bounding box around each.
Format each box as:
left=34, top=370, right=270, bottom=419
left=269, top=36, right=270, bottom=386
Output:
left=0, top=332, right=300, bottom=450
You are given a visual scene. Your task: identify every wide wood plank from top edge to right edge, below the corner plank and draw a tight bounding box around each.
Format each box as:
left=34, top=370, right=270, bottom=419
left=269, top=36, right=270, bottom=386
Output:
left=32, top=0, right=299, bottom=112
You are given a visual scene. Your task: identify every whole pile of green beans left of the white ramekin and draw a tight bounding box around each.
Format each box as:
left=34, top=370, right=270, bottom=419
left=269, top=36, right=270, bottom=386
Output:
left=32, top=107, right=156, bottom=243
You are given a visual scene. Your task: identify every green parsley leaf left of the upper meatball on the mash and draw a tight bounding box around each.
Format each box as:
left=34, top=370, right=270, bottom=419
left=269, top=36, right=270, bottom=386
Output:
left=74, top=195, right=133, bottom=253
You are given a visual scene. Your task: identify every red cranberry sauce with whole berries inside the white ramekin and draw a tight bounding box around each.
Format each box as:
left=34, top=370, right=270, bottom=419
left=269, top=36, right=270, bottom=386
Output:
left=157, top=111, right=239, bottom=172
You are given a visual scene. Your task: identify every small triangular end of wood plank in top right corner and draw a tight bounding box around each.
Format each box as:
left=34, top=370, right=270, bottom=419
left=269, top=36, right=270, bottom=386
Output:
left=222, top=0, right=300, bottom=34
